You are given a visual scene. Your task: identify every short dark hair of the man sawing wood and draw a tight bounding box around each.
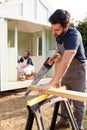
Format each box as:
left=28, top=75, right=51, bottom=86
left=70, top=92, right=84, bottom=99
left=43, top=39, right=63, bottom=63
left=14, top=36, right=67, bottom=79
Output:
left=49, top=9, right=70, bottom=27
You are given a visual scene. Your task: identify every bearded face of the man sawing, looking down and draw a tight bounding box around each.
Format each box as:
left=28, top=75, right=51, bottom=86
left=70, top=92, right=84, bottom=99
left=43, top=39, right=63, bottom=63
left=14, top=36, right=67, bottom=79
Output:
left=51, top=24, right=67, bottom=37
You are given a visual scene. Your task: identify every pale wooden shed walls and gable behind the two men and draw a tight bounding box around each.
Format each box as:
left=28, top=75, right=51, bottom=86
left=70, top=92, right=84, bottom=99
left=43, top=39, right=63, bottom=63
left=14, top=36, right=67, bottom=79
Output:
left=0, top=0, right=55, bottom=90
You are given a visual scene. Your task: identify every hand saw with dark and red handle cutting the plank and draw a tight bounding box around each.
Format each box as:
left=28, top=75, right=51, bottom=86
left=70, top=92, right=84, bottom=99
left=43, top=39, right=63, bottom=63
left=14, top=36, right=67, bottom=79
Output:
left=24, top=57, right=54, bottom=98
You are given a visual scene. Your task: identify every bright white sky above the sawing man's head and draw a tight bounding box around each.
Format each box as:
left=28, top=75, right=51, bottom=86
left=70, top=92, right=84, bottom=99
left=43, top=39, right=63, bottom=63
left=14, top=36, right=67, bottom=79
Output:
left=46, top=0, right=87, bottom=20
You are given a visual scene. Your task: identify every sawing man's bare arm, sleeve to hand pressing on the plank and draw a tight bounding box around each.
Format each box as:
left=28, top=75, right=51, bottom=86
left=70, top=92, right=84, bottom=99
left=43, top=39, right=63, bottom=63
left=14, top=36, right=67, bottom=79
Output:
left=39, top=50, right=76, bottom=92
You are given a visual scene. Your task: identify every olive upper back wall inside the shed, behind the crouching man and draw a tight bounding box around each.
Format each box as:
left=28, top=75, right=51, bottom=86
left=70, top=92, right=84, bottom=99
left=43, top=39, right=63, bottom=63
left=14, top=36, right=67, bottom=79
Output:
left=17, top=32, right=41, bottom=56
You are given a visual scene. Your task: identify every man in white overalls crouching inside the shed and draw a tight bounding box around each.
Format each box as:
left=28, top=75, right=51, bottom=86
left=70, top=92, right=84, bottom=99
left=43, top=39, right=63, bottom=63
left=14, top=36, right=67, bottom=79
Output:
left=17, top=50, right=35, bottom=79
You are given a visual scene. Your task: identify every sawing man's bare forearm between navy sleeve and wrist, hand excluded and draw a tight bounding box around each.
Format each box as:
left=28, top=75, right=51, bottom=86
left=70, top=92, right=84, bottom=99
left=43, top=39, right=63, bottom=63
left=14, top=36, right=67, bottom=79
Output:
left=50, top=50, right=76, bottom=85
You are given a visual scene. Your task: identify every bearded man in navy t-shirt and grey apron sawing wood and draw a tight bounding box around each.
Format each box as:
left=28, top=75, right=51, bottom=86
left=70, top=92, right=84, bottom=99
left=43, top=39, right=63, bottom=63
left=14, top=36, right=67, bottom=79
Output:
left=39, top=9, right=87, bottom=130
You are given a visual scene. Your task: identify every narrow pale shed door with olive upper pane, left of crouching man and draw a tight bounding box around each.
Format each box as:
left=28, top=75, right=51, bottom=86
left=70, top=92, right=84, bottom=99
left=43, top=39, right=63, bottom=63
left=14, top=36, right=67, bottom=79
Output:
left=8, top=29, right=18, bottom=81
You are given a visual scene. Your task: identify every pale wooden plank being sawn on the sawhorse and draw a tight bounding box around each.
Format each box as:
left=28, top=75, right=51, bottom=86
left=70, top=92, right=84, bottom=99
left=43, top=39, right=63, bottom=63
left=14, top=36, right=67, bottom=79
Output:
left=29, top=86, right=87, bottom=102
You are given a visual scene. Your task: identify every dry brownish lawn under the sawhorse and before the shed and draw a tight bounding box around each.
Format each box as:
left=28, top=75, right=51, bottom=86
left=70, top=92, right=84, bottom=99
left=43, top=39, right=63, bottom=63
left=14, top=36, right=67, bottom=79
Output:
left=0, top=91, right=87, bottom=130
